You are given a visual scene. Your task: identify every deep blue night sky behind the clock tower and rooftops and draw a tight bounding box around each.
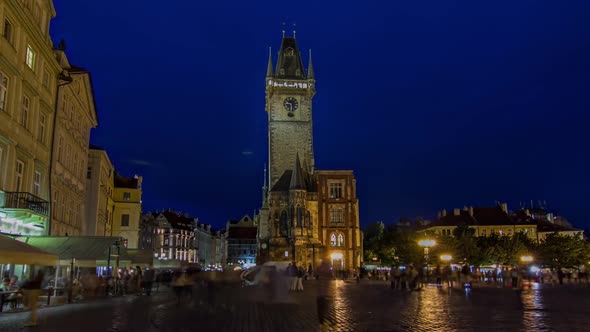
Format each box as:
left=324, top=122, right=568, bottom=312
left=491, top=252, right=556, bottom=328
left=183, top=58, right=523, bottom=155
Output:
left=51, top=0, right=590, bottom=227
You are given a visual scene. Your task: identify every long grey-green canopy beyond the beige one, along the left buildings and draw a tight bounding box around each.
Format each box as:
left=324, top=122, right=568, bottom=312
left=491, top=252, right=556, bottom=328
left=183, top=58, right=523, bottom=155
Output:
left=17, top=236, right=125, bottom=267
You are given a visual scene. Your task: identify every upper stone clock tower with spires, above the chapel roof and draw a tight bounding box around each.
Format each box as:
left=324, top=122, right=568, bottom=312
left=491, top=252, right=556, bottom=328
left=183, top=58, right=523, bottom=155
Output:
left=266, top=36, right=315, bottom=188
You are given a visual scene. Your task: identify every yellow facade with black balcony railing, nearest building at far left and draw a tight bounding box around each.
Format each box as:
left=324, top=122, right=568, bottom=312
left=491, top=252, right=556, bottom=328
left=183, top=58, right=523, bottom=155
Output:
left=0, top=0, right=62, bottom=235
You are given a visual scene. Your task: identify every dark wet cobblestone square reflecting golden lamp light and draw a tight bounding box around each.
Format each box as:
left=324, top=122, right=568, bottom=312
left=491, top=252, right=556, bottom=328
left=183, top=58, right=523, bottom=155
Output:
left=0, top=281, right=590, bottom=332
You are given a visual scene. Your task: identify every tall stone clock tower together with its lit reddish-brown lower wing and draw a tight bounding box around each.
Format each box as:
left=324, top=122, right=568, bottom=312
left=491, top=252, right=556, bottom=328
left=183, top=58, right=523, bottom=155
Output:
left=257, top=36, right=362, bottom=270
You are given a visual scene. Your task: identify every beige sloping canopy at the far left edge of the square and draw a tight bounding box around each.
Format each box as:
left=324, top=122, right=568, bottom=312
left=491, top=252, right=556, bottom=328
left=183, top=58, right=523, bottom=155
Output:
left=0, top=235, right=58, bottom=266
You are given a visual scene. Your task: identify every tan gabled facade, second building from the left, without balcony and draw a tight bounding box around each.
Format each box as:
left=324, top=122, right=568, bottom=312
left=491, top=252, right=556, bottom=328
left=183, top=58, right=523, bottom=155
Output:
left=50, top=50, right=98, bottom=236
